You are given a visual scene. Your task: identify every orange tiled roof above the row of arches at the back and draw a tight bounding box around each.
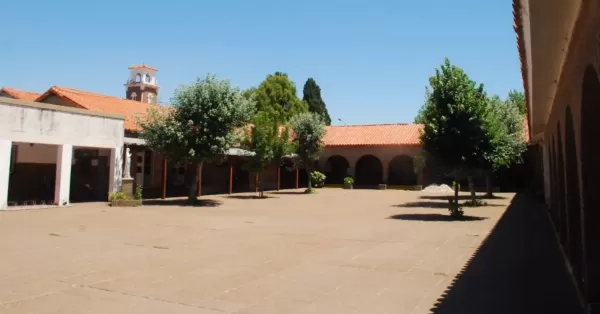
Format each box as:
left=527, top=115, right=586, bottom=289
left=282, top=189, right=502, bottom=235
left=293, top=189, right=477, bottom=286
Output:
left=323, top=124, right=423, bottom=146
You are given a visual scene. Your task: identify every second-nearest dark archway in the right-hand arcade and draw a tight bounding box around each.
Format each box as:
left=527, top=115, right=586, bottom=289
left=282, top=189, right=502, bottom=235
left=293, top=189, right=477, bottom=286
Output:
left=565, top=106, right=583, bottom=285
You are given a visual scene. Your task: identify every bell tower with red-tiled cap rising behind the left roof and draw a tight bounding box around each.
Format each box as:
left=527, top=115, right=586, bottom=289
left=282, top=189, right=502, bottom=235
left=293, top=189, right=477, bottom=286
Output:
left=125, top=64, right=159, bottom=104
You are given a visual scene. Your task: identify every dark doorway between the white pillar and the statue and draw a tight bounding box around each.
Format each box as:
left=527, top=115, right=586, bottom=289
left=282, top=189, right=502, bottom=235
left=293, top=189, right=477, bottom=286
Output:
left=70, top=148, right=110, bottom=203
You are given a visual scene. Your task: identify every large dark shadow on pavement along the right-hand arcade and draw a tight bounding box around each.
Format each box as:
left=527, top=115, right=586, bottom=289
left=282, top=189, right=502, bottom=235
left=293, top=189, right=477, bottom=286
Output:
left=431, top=194, right=583, bottom=314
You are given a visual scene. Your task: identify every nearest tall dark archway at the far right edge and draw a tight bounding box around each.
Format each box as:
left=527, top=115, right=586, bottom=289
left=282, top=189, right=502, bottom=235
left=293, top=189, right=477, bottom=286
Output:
left=580, top=65, right=600, bottom=302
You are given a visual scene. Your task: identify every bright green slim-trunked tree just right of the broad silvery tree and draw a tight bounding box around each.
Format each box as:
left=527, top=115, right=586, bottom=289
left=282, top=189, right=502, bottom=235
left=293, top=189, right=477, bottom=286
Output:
left=243, top=112, right=292, bottom=198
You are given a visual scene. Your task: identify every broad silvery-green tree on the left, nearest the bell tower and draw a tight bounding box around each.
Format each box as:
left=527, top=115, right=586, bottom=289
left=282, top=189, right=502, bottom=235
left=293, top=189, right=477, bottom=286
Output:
left=139, top=74, right=255, bottom=200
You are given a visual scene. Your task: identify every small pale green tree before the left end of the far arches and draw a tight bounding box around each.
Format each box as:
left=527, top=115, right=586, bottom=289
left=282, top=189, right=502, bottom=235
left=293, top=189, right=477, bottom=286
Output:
left=289, top=112, right=325, bottom=193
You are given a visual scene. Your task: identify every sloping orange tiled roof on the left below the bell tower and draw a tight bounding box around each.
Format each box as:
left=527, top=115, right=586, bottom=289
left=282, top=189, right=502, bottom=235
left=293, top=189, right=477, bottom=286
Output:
left=36, top=86, right=155, bottom=131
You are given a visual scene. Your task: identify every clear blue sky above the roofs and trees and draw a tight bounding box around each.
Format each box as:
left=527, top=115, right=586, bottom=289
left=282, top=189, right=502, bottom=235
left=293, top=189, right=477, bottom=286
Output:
left=0, top=0, right=522, bottom=124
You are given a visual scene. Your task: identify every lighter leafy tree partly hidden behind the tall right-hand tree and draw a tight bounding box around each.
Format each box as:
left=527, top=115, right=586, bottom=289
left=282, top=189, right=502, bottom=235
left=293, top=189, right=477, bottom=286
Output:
left=484, top=94, right=527, bottom=197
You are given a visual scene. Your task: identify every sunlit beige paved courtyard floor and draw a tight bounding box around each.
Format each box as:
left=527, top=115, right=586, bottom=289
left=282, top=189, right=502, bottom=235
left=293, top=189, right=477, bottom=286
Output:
left=0, top=189, right=572, bottom=314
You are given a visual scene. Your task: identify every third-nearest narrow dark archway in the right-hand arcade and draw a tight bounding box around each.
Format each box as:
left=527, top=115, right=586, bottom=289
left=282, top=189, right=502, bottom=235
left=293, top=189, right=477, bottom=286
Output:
left=556, top=122, right=570, bottom=248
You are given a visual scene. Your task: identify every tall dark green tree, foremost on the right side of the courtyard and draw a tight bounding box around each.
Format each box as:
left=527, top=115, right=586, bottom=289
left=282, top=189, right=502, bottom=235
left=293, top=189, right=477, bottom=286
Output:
left=421, top=58, right=490, bottom=215
